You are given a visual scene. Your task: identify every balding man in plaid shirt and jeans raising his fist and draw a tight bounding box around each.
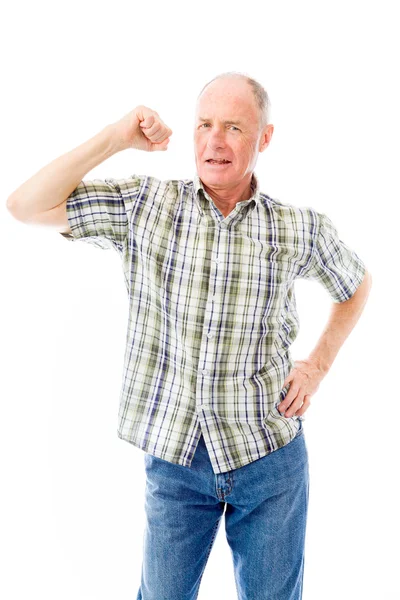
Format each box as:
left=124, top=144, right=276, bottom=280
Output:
left=8, top=73, right=371, bottom=600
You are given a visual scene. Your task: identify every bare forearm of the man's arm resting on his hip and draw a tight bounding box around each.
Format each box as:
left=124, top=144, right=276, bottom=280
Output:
left=309, top=272, right=372, bottom=373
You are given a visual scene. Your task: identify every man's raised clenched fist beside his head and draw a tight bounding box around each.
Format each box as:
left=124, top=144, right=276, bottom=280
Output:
left=114, top=105, right=172, bottom=152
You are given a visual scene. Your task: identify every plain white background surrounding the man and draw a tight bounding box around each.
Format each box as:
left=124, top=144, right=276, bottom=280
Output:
left=0, top=0, right=400, bottom=600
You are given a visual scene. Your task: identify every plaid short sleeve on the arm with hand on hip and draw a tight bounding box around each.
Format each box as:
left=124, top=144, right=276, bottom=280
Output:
left=299, top=213, right=366, bottom=303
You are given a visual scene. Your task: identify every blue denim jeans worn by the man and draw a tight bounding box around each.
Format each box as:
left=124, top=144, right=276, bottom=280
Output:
left=136, top=422, right=309, bottom=600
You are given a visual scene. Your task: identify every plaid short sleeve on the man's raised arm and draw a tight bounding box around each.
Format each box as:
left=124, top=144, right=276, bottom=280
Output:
left=59, top=175, right=140, bottom=250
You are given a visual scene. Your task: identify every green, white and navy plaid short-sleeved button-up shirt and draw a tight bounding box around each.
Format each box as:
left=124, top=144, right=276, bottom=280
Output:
left=60, top=173, right=366, bottom=474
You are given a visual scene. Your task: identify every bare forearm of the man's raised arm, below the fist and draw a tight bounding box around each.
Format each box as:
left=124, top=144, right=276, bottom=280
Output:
left=7, top=125, right=120, bottom=220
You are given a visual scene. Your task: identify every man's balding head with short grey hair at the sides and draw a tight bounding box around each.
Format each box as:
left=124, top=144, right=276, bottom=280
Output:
left=194, top=73, right=274, bottom=189
